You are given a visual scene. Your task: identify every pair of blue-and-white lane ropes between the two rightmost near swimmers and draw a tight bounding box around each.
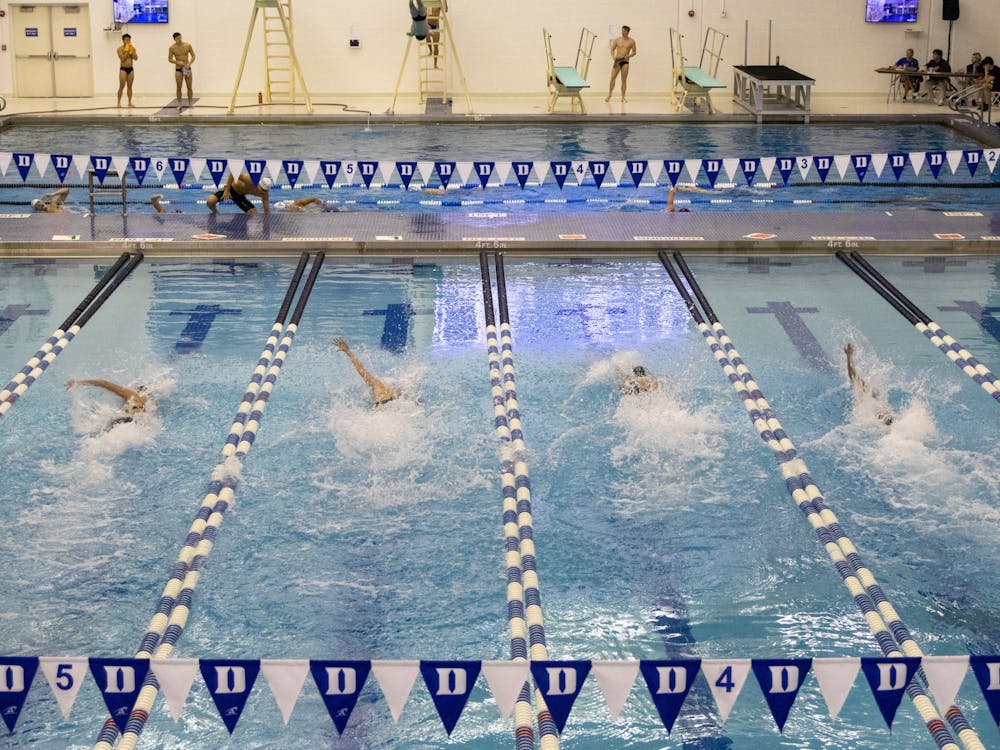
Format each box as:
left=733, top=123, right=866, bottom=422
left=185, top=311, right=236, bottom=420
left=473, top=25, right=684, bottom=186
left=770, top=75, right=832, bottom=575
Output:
left=660, top=253, right=985, bottom=750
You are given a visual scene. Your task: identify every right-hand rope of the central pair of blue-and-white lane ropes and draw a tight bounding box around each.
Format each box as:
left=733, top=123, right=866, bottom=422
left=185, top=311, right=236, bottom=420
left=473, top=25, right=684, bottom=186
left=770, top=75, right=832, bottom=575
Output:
left=494, top=253, right=559, bottom=750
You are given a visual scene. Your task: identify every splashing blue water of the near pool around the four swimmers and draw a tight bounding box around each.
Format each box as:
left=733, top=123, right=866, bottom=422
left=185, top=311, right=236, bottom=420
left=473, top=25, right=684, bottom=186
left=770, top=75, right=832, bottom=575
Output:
left=0, top=256, right=1000, bottom=750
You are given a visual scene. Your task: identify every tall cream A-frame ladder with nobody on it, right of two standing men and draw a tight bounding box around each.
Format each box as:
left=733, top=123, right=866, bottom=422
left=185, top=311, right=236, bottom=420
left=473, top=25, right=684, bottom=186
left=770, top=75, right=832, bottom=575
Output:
left=229, top=0, right=313, bottom=114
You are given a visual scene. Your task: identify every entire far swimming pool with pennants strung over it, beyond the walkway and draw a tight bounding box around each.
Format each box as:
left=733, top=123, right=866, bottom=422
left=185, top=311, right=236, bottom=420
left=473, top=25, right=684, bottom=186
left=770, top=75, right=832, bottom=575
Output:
left=0, top=117, right=1000, bottom=213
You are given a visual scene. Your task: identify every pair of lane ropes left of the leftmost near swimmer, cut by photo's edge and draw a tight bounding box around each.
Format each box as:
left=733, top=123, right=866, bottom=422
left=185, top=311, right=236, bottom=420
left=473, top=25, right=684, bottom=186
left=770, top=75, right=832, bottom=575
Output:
left=0, top=253, right=142, bottom=417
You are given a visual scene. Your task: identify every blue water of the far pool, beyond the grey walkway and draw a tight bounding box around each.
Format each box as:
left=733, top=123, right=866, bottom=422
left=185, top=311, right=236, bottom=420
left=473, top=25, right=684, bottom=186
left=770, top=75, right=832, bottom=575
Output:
left=0, top=122, right=997, bottom=213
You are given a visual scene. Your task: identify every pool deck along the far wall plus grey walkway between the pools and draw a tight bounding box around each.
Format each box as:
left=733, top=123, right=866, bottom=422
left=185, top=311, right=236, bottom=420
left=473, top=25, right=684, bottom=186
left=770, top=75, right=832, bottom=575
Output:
left=0, top=94, right=1000, bottom=257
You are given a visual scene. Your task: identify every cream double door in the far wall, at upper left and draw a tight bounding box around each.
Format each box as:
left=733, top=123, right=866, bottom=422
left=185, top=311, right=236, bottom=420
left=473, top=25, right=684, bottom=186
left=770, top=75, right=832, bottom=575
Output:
left=10, top=3, right=94, bottom=97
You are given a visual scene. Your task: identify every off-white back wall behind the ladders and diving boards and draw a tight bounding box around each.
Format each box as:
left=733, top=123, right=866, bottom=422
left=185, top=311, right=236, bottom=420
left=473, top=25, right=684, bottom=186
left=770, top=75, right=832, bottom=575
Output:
left=0, top=0, right=1000, bottom=99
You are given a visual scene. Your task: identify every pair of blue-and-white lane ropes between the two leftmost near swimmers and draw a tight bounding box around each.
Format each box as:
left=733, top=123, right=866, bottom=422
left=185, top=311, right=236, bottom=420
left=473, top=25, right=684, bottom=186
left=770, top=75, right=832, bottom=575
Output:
left=94, top=253, right=323, bottom=750
